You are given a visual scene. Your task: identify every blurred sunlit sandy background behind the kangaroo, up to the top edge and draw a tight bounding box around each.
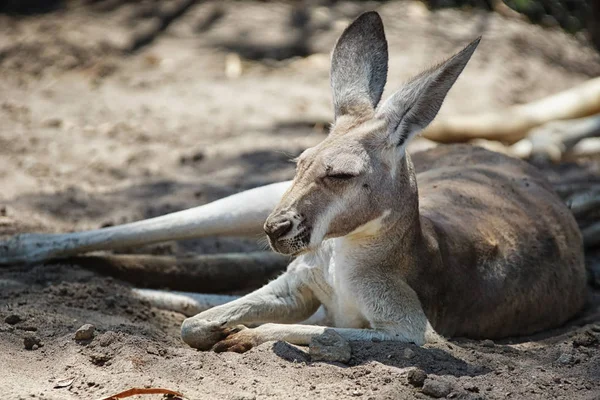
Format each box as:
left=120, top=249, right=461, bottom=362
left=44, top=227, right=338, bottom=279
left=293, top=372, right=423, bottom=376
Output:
left=0, top=0, right=600, bottom=254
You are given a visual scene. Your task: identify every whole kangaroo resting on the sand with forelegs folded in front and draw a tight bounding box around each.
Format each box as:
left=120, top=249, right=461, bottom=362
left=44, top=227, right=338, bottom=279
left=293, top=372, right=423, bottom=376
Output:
left=181, top=12, right=586, bottom=352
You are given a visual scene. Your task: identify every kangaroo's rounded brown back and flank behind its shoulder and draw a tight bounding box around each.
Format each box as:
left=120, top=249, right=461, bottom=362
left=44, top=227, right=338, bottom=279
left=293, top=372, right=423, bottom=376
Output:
left=411, top=145, right=586, bottom=337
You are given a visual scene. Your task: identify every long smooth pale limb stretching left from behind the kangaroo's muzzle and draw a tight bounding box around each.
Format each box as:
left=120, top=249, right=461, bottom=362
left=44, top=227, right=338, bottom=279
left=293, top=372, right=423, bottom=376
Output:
left=0, top=182, right=290, bottom=264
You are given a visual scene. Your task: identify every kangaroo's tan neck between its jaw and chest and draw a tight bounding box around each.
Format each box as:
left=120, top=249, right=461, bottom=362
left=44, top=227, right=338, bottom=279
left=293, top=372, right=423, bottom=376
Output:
left=336, top=154, right=423, bottom=266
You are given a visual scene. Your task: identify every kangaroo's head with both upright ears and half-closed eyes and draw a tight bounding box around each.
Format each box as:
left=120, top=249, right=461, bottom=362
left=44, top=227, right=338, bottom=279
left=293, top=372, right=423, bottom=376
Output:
left=264, top=12, right=480, bottom=254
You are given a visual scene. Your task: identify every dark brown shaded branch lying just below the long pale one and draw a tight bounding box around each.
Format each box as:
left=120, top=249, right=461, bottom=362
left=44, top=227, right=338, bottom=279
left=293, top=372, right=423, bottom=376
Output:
left=50, top=252, right=289, bottom=293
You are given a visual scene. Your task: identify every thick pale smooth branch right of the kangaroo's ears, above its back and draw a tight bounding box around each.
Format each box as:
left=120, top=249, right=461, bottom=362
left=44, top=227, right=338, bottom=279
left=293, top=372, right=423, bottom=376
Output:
left=423, top=78, right=600, bottom=143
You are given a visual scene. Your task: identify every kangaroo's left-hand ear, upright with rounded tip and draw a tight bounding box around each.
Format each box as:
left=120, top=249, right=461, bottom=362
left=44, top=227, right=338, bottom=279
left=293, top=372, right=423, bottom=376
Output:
left=331, top=11, right=388, bottom=118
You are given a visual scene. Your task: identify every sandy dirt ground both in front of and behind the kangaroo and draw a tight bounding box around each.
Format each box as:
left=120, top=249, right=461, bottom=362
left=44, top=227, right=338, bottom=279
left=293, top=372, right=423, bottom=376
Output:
left=0, top=1, right=600, bottom=400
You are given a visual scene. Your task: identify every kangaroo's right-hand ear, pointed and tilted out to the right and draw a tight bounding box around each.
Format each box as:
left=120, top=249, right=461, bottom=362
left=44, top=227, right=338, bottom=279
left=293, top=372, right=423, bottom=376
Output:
left=377, top=37, right=481, bottom=146
